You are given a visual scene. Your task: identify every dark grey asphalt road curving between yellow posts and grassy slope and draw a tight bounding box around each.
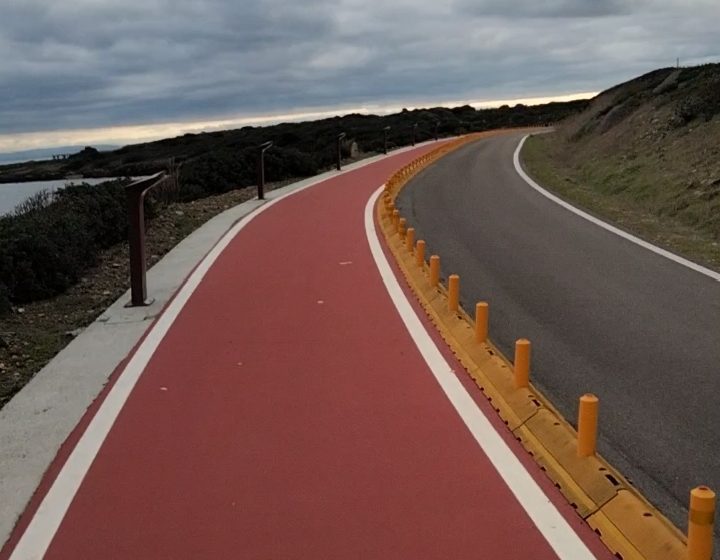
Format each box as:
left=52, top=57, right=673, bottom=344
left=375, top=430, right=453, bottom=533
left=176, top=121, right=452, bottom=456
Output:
left=398, top=134, right=720, bottom=527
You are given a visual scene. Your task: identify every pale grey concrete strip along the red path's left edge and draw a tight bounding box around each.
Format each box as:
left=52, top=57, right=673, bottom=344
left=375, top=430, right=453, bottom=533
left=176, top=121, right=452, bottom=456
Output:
left=0, top=141, right=434, bottom=545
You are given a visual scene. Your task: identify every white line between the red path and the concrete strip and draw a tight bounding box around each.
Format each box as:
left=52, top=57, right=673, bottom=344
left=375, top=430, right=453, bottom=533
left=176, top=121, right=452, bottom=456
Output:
left=5, top=144, right=430, bottom=560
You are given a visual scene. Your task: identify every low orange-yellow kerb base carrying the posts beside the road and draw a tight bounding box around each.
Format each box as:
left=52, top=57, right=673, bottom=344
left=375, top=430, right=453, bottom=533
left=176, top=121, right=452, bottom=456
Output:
left=376, top=131, right=685, bottom=560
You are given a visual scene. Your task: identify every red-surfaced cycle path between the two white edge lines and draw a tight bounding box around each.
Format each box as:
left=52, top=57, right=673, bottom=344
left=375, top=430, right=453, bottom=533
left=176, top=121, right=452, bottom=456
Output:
left=5, top=147, right=611, bottom=560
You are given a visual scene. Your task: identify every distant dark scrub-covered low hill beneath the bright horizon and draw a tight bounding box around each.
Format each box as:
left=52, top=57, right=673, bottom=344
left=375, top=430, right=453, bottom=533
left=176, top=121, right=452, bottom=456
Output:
left=0, top=100, right=587, bottom=187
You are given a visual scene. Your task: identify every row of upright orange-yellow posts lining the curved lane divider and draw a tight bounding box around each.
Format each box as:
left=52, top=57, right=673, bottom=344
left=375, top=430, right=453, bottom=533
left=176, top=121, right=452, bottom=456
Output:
left=383, top=149, right=716, bottom=560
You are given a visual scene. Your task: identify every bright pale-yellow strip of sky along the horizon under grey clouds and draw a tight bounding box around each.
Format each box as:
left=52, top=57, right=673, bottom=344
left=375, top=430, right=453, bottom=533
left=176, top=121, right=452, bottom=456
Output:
left=0, top=92, right=599, bottom=156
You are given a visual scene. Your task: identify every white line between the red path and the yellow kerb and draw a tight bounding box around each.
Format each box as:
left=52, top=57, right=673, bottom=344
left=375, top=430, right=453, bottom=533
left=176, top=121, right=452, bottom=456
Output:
left=365, top=187, right=595, bottom=560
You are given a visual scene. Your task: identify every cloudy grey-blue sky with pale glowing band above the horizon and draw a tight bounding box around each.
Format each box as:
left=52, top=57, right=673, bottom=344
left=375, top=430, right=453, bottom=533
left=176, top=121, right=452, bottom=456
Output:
left=0, top=0, right=720, bottom=152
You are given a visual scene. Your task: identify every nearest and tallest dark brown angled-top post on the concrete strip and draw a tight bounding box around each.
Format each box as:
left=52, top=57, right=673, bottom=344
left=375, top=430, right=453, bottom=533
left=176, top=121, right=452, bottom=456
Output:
left=125, top=171, right=166, bottom=307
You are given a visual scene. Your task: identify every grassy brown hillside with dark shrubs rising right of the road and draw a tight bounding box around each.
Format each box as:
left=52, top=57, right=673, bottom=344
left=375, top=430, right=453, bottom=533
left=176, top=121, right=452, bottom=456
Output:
left=523, top=64, right=720, bottom=269
